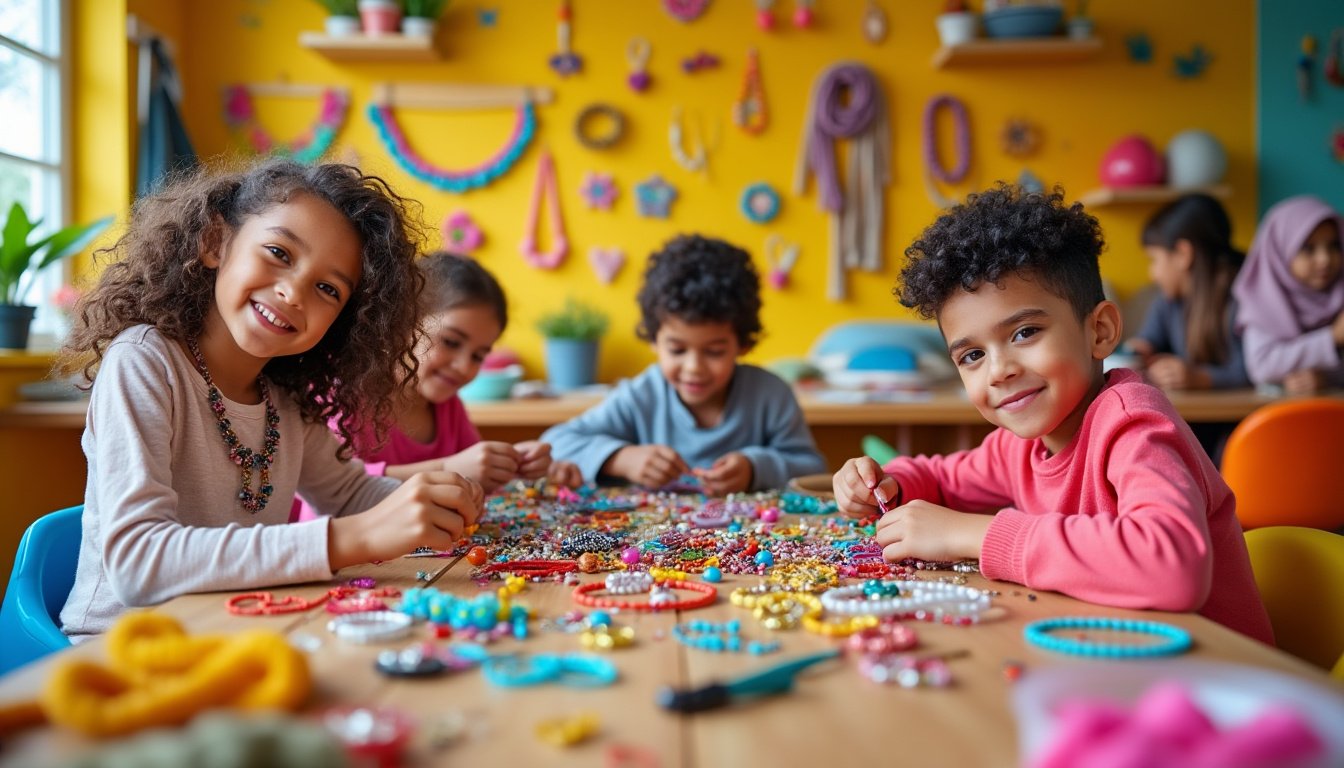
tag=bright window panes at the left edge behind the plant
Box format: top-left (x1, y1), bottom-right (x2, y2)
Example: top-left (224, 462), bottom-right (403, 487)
top-left (0, 0), bottom-right (70, 348)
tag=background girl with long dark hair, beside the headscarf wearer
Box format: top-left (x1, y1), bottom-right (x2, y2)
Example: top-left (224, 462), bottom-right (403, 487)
top-left (1125, 195), bottom-right (1251, 390)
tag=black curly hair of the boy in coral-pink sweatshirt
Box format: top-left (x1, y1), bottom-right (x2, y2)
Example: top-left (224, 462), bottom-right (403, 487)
top-left (892, 184), bottom-right (1105, 320)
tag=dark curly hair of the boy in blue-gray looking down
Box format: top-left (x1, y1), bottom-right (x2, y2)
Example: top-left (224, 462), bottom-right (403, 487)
top-left (634, 234), bottom-right (761, 352)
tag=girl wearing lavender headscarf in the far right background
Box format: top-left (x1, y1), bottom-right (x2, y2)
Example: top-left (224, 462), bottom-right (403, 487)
top-left (1232, 195), bottom-right (1344, 394)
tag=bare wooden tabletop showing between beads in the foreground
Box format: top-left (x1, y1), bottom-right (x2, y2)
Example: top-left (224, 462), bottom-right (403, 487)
top-left (0, 519), bottom-right (1344, 768)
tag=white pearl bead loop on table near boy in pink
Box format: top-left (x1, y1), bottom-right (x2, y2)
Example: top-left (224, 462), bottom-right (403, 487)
top-left (821, 581), bottom-right (989, 625)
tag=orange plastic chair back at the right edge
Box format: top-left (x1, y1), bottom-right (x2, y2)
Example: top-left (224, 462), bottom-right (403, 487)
top-left (1222, 397), bottom-right (1344, 530)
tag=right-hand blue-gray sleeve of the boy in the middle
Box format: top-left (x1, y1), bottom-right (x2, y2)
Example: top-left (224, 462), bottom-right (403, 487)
top-left (742, 371), bottom-right (827, 491)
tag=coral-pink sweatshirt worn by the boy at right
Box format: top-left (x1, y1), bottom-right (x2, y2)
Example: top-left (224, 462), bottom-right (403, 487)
top-left (886, 370), bottom-right (1274, 644)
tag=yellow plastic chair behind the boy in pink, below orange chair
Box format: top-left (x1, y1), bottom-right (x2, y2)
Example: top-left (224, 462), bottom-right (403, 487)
top-left (1246, 526), bottom-right (1344, 681)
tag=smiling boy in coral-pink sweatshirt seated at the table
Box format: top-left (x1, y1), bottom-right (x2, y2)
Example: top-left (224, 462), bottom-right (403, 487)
top-left (833, 187), bottom-right (1273, 643)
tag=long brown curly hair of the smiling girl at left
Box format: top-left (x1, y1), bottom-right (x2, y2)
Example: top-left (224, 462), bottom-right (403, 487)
top-left (59, 160), bottom-right (423, 456)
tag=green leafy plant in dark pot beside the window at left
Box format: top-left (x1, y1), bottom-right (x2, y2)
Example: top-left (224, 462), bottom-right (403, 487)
top-left (0, 203), bottom-right (113, 350)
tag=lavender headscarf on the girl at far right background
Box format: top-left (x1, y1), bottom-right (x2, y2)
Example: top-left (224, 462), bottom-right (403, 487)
top-left (1232, 195), bottom-right (1344, 339)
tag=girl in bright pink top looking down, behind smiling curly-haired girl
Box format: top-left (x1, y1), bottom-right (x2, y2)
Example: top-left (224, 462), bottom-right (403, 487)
top-left (298, 252), bottom-right (581, 519)
